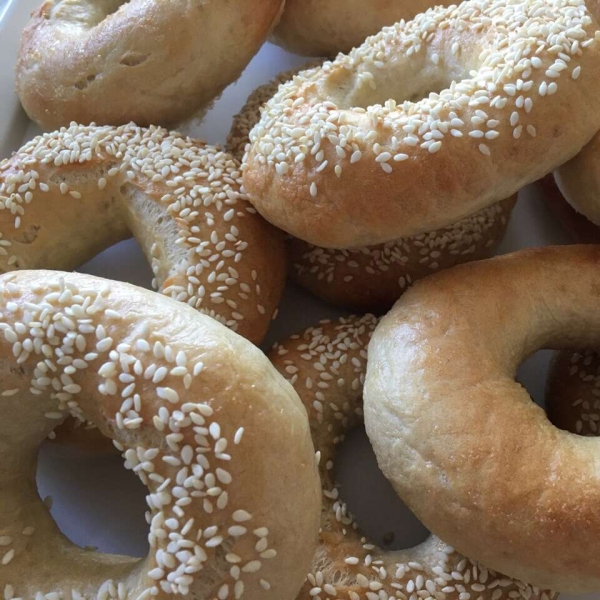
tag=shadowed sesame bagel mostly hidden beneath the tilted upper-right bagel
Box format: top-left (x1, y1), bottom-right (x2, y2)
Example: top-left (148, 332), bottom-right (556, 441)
top-left (226, 68), bottom-right (516, 313)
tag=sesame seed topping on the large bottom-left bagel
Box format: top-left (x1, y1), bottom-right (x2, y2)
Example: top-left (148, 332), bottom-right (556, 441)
top-left (0, 274), bottom-right (277, 600)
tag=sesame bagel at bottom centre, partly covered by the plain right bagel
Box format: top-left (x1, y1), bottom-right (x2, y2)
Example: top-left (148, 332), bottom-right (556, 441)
top-left (269, 315), bottom-right (556, 600)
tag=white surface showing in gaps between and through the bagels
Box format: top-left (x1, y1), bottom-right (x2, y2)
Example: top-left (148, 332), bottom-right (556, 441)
top-left (0, 0), bottom-right (600, 600)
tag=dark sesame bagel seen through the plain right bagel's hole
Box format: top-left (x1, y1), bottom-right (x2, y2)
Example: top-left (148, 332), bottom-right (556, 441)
top-left (546, 350), bottom-right (600, 437)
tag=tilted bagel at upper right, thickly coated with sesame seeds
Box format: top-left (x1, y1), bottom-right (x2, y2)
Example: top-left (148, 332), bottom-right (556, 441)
top-left (244, 0), bottom-right (600, 248)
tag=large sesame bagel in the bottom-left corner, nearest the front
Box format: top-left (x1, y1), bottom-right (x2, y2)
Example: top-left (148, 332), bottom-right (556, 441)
top-left (0, 271), bottom-right (320, 600)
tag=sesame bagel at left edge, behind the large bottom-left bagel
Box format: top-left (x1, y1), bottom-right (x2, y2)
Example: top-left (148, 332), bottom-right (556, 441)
top-left (0, 124), bottom-right (286, 343)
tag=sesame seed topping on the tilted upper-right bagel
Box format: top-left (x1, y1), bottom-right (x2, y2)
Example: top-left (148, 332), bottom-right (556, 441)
top-left (245, 0), bottom-right (597, 231)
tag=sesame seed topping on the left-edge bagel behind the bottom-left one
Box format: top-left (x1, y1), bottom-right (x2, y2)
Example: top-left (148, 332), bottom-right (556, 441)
top-left (0, 124), bottom-right (277, 342)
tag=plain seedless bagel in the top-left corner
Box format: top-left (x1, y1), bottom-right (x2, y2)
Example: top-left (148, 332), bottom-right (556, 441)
top-left (17, 0), bottom-right (283, 129)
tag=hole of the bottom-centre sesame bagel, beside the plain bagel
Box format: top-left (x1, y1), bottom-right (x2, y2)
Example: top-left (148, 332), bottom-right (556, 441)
top-left (334, 427), bottom-right (429, 550)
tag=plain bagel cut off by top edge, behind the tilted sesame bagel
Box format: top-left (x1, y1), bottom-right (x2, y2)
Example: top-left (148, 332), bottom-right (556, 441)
top-left (270, 0), bottom-right (439, 56)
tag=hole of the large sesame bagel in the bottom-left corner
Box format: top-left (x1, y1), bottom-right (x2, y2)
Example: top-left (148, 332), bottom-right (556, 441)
top-left (37, 432), bottom-right (148, 558)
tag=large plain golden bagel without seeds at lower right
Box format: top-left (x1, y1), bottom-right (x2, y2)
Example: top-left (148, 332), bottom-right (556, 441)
top-left (365, 246), bottom-right (600, 593)
